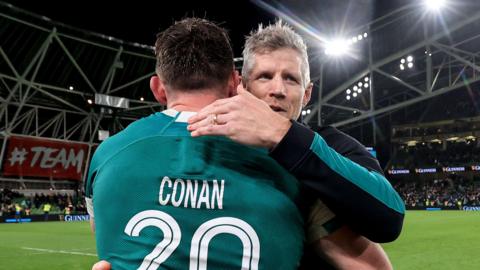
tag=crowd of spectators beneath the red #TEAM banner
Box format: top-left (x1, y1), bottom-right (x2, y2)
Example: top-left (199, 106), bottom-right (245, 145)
top-left (0, 189), bottom-right (87, 216)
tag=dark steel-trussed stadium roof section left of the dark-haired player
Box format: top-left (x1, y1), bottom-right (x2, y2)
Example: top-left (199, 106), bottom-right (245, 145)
top-left (0, 1), bottom-right (278, 144)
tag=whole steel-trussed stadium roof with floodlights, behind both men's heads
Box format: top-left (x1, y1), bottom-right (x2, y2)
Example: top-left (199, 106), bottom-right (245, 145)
top-left (0, 0), bottom-right (480, 148)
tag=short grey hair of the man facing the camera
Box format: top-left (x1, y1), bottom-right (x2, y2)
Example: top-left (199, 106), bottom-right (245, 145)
top-left (242, 20), bottom-right (310, 88)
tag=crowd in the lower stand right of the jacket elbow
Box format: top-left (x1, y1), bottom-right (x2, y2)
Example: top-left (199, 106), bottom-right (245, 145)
top-left (395, 175), bottom-right (480, 209)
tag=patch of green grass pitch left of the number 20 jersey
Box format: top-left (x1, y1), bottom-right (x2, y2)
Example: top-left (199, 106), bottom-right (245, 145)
top-left (0, 221), bottom-right (98, 270)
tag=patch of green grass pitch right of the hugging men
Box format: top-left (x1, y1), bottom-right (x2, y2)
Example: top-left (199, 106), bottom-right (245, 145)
top-left (383, 211), bottom-right (480, 270)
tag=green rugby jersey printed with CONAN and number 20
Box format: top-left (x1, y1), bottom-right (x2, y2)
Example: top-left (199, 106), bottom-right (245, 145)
top-left (85, 110), bottom-right (304, 270)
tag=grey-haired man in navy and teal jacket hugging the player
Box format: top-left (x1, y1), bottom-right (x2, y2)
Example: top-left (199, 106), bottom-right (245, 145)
top-left (189, 22), bottom-right (405, 269)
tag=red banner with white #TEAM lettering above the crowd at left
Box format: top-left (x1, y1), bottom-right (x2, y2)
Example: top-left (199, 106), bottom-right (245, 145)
top-left (2, 136), bottom-right (88, 180)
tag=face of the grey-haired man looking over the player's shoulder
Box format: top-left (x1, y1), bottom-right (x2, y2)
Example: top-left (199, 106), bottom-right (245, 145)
top-left (247, 48), bottom-right (312, 120)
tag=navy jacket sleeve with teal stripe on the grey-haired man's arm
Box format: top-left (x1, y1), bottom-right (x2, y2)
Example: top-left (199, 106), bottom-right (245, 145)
top-left (270, 121), bottom-right (405, 243)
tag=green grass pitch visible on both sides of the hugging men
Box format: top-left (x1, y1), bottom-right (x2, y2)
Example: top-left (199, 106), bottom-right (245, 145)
top-left (0, 211), bottom-right (480, 270)
